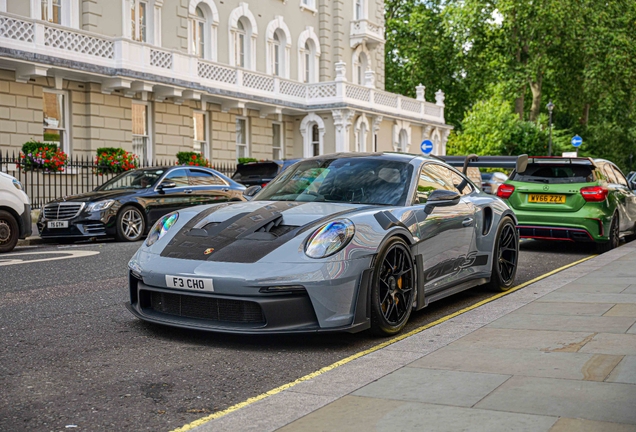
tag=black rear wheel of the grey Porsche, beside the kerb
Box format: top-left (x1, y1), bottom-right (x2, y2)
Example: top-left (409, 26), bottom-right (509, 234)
top-left (486, 217), bottom-right (519, 292)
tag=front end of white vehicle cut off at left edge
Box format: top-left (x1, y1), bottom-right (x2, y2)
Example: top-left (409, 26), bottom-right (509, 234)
top-left (0, 172), bottom-right (31, 252)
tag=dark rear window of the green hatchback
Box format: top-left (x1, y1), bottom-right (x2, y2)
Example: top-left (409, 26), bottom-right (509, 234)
top-left (510, 163), bottom-right (595, 184)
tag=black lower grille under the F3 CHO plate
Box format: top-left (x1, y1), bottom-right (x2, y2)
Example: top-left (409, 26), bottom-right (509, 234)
top-left (149, 291), bottom-right (265, 324)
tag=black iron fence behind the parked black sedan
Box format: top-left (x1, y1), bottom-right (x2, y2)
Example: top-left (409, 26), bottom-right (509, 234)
top-left (0, 151), bottom-right (236, 209)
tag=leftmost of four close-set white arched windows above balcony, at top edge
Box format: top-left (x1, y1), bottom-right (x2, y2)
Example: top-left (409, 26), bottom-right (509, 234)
top-left (188, 0), bottom-right (219, 61)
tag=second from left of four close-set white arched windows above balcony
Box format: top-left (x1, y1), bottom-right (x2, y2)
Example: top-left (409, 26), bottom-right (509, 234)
top-left (229, 3), bottom-right (258, 69)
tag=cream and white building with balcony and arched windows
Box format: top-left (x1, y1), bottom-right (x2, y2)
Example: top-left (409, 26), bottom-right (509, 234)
top-left (0, 0), bottom-right (451, 162)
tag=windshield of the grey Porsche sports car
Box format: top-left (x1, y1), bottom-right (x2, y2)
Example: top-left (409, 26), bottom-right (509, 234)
top-left (255, 157), bottom-right (413, 205)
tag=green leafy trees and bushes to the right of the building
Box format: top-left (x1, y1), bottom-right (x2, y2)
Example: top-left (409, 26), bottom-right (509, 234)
top-left (385, 0), bottom-right (636, 170)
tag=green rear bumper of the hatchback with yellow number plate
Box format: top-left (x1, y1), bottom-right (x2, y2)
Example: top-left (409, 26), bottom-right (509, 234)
top-left (514, 208), bottom-right (612, 242)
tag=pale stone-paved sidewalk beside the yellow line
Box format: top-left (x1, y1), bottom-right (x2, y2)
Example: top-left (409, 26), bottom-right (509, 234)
top-left (195, 242), bottom-right (636, 432)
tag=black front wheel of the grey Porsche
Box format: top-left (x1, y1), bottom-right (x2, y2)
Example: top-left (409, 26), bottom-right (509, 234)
top-left (371, 237), bottom-right (415, 336)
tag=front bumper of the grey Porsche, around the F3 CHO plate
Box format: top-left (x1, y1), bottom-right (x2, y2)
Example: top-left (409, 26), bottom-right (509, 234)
top-left (126, 255), bottom-right (372, 334)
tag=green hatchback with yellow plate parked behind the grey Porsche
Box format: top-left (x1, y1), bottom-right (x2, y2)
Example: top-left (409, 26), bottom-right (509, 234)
top-left (497, 157), bottom-right (636, 252)
